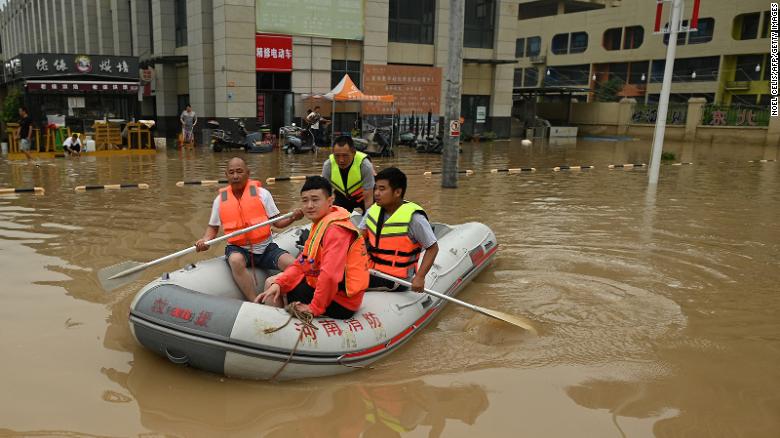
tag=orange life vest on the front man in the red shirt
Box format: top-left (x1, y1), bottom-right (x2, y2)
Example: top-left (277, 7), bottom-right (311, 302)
top-left (297, 206), bottom-right (368, 297)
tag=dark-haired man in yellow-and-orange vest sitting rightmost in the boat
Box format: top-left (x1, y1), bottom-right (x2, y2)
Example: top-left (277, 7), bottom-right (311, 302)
top-left (358, 167), bottom-right (439, 292)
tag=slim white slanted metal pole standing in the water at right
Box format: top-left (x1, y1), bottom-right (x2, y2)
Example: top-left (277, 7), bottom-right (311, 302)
top-left (649, 0), bottom-right (682, 184)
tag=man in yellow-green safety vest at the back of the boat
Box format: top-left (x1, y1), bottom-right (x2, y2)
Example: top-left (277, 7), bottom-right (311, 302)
top-left (322, 135), bottom-right (374, 213)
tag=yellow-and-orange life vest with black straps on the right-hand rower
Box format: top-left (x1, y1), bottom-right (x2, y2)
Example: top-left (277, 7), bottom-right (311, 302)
top-left (366, 201), bottom-right (428, 279)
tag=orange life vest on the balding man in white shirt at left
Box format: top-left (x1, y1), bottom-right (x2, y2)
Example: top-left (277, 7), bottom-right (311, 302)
top-left (219, 179), bottom-right (271, 245)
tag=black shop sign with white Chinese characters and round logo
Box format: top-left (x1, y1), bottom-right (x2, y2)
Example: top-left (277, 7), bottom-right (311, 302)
top-left (20, 53), bottom-right (139, 79)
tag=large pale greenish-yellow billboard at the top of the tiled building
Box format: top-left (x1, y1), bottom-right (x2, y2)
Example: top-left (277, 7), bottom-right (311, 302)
top-left (255, 0), bottom-right (363, 40)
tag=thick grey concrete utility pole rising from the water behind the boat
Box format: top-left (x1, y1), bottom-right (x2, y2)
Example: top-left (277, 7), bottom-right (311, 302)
top-left (441, 0), bottom-right (466, 188)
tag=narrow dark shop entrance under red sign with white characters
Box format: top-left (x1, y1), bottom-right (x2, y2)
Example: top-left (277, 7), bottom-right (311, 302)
top-left (255, 34), bottom-right (293, 132)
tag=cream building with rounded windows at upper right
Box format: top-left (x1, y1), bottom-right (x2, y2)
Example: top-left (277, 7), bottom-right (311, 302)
top-left (513, 0), bottom-right (769, 106)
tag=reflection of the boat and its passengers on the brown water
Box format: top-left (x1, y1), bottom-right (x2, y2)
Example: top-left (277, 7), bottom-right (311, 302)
top-left (101, 342), bottom-right (489, 437)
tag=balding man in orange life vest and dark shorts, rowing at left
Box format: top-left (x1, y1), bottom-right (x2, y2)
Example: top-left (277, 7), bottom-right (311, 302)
top-left (195, 157), bottom-right (303, 301)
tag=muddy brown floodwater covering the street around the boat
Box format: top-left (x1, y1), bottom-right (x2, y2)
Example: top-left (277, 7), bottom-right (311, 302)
top-left (0, 140), bottom-right (780, 437)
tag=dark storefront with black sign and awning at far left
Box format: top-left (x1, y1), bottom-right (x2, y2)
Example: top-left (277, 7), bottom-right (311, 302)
top-left (3, 53), bottom-right (140, 132)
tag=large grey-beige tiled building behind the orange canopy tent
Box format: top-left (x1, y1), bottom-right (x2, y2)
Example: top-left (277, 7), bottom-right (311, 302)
top-left (0, 0), bottom-right (518, 136)
